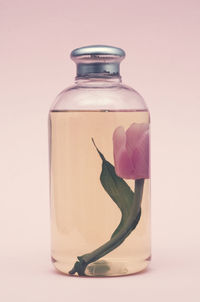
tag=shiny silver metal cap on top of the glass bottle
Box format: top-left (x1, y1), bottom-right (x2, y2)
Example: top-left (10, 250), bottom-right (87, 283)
top-left (71, 45), bottom-right (126, 78)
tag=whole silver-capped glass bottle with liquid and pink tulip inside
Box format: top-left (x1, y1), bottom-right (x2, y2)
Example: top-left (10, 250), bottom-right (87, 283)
top-left (49, 45), bottom-right (151, 277)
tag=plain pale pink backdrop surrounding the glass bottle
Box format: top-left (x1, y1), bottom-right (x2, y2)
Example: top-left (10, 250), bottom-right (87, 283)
top-left (0, 0), bottom-right (200, 302)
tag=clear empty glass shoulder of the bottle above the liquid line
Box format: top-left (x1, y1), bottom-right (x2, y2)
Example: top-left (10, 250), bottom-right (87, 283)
top-left (51, 83), bottom-right (148, 111)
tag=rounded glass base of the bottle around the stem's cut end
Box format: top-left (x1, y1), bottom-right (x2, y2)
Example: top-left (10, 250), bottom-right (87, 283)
top-left (52, 257), bottom-right (150, 277)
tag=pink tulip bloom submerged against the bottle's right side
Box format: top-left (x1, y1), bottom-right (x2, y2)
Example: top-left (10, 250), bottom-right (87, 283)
top-left (113, 123), bottom-right (149, 179)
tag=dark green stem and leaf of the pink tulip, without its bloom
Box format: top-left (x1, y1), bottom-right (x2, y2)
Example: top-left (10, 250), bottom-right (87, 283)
top-left (69, 139), bottom-right (144, 275)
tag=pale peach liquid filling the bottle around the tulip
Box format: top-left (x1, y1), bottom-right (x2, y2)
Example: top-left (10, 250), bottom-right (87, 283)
top-left (50, 111), bottom-right (151, 276)
